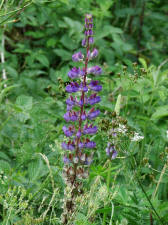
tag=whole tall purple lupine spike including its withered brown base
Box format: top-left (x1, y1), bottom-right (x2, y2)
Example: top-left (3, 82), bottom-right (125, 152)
top-left (62, 14), bottom-right (102, 224)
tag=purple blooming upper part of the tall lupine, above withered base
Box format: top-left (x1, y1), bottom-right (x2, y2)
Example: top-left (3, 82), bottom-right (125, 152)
top-left (62, 14), bottom-right (102, 178)
